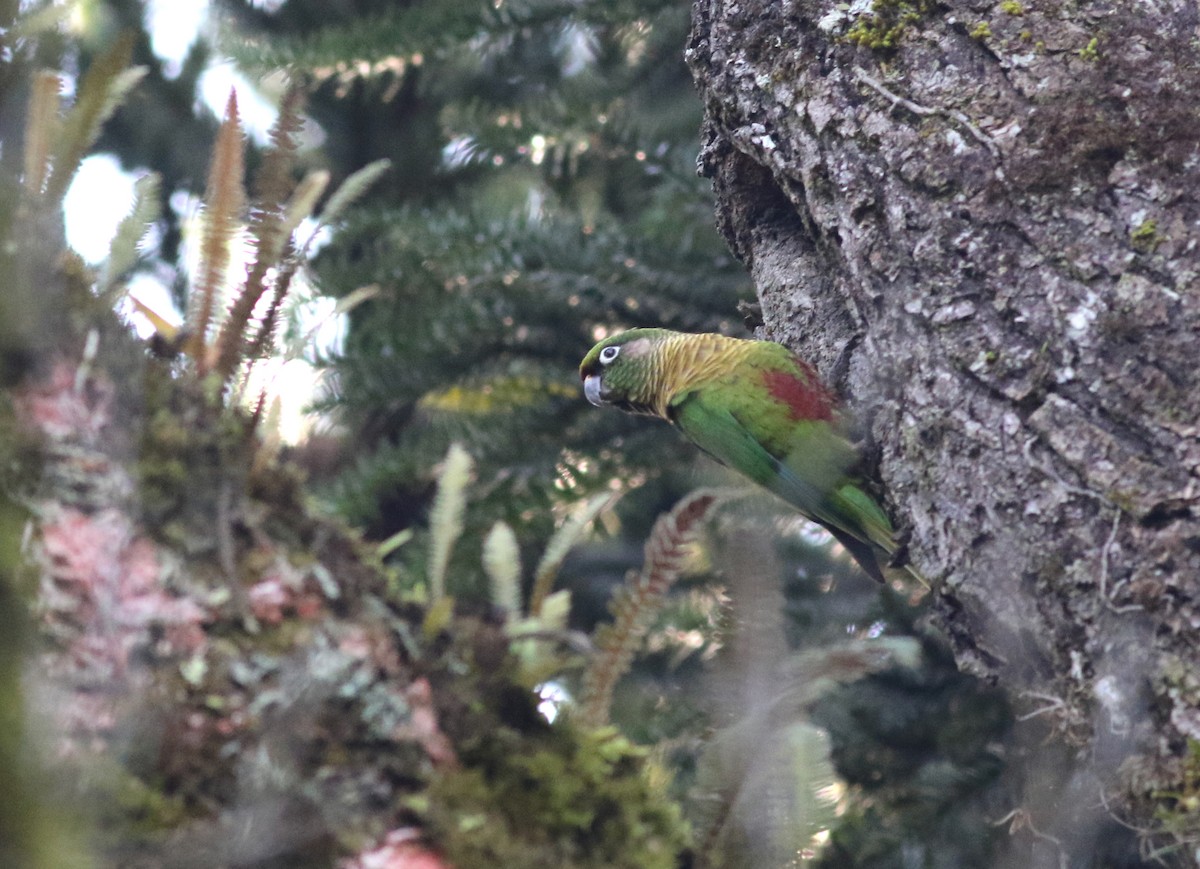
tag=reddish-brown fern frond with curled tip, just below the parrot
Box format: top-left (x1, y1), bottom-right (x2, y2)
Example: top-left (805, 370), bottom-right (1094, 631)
top-left (580, 490), bottom-right (718, 727)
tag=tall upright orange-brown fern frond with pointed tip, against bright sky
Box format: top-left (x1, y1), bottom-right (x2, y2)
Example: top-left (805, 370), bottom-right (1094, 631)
top-left (184, 91), bottom-right (246, 374)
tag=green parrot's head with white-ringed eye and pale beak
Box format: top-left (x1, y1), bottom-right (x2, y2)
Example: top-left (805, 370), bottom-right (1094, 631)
top-left (580, 329), bottom-right (672, 415)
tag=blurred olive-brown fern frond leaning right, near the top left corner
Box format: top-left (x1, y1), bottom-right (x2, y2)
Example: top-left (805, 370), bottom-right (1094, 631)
top-left (46, 32), bottom-right (146, 203)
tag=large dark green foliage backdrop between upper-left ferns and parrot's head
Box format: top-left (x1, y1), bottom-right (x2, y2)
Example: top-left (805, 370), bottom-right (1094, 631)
top-left (213, 0), bottom-right (749, 566)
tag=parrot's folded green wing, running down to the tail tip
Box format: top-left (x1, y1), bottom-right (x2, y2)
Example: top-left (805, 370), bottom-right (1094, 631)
top-left (671, 390), bottom-right (895, 582)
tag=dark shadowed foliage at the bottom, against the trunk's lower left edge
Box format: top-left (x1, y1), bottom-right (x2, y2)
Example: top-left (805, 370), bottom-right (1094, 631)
top-left (812, 633), bottom-right (1010, 868)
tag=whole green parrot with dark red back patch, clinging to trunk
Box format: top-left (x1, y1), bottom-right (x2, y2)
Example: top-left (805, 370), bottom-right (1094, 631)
top-left (580, 329), bottom-right (919, 582)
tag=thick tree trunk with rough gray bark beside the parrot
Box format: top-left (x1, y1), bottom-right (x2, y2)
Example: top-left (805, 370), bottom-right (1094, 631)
top-left (688, 0), bottom-right (1200, 865)
